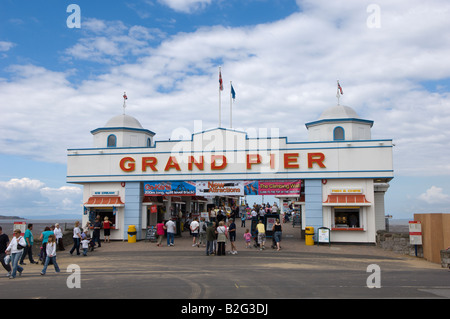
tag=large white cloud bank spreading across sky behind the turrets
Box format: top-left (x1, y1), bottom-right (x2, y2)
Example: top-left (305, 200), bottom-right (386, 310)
top-left (0, 0), bottom-right (450, 180)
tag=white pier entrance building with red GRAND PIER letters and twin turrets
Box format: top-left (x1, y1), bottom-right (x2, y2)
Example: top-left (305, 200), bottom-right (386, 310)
top-left (67, 105), bottom-right (394, 243)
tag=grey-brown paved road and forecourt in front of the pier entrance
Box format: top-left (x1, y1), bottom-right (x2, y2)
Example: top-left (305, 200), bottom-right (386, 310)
top-left (0, 227), bottom-right (450, 302)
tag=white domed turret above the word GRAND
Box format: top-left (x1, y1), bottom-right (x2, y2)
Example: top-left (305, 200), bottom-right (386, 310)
top-left (91, 114), bottom-right (155, 148)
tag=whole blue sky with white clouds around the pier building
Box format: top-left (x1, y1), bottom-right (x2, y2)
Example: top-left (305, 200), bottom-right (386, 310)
top-left (0, 0), bottom-right (450, 218)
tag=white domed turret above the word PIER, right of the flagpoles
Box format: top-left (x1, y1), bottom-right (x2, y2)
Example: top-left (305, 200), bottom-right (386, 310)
top-left (305, 105), bottom-right (373, 141)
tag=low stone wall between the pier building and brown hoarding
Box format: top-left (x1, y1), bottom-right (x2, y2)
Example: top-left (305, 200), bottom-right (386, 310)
top-left (377, 230), bottom-right (423, 258)
